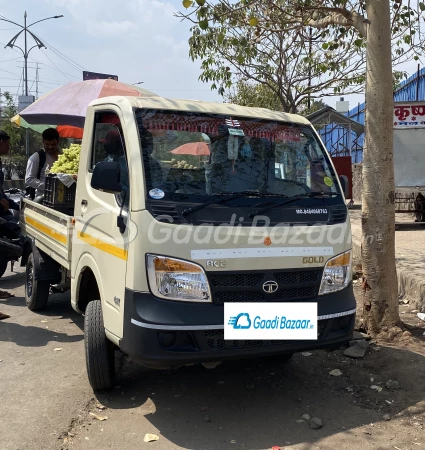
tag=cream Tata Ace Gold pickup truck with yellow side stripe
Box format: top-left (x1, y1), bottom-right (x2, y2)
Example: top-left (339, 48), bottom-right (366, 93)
top-left (21, 97), bottom-right (356, 389)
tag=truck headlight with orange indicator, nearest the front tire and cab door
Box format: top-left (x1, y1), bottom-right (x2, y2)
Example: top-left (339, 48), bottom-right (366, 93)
top-left (147, 255), bottom-right (211, 302)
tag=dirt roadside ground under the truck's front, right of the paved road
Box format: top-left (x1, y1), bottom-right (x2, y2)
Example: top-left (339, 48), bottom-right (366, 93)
top-left (63, 288), bottom-right (425, 450)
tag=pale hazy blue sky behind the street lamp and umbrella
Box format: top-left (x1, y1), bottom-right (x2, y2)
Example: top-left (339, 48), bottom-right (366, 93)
top-left (0, 0), bottom-right (416, 114)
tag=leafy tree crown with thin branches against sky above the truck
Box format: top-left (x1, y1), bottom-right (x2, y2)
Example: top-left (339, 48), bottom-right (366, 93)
top-left (177, 0), bottom-right (425, 114)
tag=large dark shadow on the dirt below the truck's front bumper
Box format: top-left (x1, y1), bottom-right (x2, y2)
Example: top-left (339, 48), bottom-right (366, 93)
top-left (93, 347), bottom-right (425, 449)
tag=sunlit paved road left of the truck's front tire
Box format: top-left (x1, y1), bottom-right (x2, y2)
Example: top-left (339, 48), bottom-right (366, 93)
top-left (0, 268), bottom-right (93, 450)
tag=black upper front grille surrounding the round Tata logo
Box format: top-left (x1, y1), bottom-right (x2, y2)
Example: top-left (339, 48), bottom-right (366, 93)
top-left (207, 268), bottom-right (323, 305)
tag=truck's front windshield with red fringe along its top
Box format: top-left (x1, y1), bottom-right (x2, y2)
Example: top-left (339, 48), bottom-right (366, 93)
top-left (136, 109), bottom-right (338, 201)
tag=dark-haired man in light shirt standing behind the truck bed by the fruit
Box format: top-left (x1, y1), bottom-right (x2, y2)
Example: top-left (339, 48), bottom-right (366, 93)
top-left (25, 128), bottom-right (59, 198)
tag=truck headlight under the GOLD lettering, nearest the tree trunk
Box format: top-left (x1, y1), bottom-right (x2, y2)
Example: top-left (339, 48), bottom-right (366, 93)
top-left (319, 250), bottom-right (352, 295)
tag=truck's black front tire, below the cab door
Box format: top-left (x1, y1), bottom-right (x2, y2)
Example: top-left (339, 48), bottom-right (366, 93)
top-left (84, 300), bottom-right (115, 391)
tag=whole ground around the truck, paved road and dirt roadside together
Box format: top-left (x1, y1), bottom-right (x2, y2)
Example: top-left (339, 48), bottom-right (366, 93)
top-left (0, 273), bottom-right (425, 450)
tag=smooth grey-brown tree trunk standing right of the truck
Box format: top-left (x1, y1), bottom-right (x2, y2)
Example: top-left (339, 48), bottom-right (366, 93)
top-left (362, 0), bottom-right (400, 334)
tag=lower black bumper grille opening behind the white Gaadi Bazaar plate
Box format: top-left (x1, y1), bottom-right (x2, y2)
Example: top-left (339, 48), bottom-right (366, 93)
top-left (204, 320), bottom-right (328, 350)
